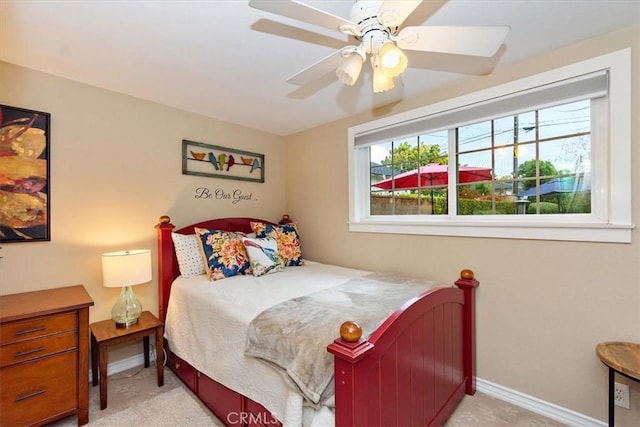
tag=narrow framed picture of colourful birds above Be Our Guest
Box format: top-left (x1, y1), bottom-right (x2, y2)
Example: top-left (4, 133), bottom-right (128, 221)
top-left (182, 139), bottom-right (264, 182)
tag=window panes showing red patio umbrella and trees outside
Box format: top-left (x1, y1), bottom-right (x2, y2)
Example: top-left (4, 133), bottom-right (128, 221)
top-left (369, 98), bottom-right (606, 215)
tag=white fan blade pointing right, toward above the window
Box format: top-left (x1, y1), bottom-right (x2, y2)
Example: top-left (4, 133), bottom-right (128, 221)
top-left (395, 26), bottom-right (510, 56)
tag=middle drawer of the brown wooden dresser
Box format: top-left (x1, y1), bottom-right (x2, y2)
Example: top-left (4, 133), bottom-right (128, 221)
top-left (0, 332), bottom-right (78, 367)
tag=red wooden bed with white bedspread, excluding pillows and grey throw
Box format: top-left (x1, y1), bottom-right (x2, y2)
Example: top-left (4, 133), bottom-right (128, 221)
top-left (156, 216), bottom-right (478, 426)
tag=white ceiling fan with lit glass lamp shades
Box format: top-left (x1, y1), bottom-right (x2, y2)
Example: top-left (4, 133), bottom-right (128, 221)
top-left (249, 0), bottom-right (510, 92)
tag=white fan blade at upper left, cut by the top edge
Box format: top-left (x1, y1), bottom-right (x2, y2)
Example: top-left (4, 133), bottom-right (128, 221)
top-left (249, 0), bottom-right (357, 31)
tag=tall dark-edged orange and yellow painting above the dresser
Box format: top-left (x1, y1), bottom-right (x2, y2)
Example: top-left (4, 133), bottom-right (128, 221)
top-left (0, 105), bottom-right (51, 243)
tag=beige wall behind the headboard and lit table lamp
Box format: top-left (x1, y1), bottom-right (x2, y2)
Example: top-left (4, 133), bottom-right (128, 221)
top-left (0, 62), bottom-right (285, 360)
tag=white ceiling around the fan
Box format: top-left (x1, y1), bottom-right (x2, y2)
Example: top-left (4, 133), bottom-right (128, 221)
top-left (0, 0), bottom-right (640, 135)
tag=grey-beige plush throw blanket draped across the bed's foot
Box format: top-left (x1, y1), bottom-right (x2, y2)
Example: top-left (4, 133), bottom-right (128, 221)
top-left (245, 273), bottom-right (436, 408)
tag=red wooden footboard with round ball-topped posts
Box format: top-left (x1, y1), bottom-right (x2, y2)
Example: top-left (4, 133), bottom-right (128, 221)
top-left (327, 271), bottom-right (478, 427)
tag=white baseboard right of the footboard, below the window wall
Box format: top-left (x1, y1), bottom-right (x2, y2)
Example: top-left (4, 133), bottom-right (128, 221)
top-left (476, 378), bottom-right (607, 427)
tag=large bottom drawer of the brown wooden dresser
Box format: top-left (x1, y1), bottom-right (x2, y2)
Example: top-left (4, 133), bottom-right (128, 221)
top-left (0, 352), bottom-right (78, 426)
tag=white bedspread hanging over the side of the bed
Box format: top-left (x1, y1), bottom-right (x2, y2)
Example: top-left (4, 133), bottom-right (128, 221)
top-left (165, 260), bottom-right (368, 427)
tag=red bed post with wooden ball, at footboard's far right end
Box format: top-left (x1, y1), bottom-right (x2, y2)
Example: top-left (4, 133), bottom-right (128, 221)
top-left (455, 270), bottom-right (480, 395)
